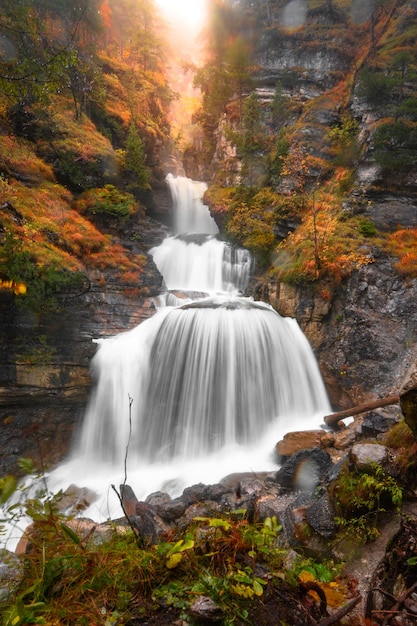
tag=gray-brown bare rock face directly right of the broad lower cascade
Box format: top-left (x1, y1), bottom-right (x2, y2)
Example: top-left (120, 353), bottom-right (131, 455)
top-left (269, 254), bottom-right (417, 408)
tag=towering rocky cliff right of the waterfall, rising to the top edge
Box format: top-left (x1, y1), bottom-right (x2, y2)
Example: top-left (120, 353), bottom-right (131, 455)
top-left (201, 2), bottom-right (417, 408)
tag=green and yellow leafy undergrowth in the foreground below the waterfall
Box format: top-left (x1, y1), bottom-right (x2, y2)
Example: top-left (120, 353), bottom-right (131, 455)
top-left (0, 461), bottom-right (348, 626)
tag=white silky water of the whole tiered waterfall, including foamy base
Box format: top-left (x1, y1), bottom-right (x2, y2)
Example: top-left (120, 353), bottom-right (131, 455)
top-left (2, 176), bottom-right (330, 544)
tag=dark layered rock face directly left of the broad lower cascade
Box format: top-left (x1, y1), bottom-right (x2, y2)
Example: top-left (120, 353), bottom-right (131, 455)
top-left (0, 212), bottom-right (166, 475)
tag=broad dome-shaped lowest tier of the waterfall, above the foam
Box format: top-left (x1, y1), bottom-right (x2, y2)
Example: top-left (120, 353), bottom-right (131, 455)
top-left (81, 296), bottom-right (326, 465)
